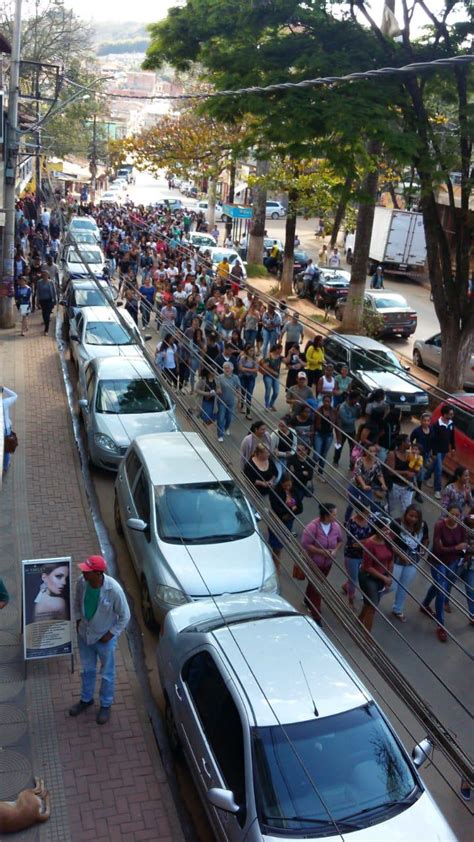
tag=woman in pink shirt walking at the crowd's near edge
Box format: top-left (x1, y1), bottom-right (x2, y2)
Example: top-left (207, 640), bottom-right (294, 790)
top-left (301, 503), bottom-right (342, 625)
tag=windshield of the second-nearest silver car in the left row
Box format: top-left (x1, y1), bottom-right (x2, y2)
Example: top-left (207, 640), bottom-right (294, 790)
top-left (155, 481), bottom-right (255, 544)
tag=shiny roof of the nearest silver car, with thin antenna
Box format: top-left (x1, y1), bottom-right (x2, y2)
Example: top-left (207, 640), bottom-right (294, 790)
top-left (212, 614), bottom-right (368, 726)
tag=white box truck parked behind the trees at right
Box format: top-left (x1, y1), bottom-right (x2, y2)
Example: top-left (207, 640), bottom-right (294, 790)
top-left (369, 207), bottom-right (426, 272)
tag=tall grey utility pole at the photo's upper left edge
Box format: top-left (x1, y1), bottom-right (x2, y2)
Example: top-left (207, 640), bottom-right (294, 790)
top-left (0, 0), bottom-right (21, 328)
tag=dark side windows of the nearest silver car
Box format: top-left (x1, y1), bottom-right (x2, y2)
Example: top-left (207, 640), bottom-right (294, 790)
top-left (183, 652), bottom-right (245, 812)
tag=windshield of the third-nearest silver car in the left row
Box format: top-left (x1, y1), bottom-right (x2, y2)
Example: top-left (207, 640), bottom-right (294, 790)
top-left (95, 378), bottom-right (169, 415)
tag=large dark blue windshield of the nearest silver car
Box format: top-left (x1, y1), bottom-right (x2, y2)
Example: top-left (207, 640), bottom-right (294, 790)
top-left (252, 703), bottom-right (420, 836)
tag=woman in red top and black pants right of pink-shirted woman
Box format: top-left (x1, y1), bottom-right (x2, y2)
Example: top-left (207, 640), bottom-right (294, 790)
top-left (359, 515), bottom-right (393, 632)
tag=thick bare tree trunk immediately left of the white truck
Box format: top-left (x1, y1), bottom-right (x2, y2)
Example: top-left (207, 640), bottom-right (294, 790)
top-left (340, 151), bottom-right (379, 334)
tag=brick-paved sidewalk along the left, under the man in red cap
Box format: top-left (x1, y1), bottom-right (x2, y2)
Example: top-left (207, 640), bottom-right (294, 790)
top-left (0, 313), bottom-right (183, 842)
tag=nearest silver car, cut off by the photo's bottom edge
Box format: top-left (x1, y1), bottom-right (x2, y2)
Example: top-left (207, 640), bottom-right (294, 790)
top-left (157, 595), bottom-right (456, 842)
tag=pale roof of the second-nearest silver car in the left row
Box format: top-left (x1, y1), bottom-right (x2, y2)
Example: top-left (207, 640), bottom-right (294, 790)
top-left (135, 432), bottom-right (230, 485)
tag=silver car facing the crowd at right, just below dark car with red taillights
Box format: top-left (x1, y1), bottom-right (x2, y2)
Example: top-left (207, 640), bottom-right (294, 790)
top-left (324, 333), bottom-right (429, 415)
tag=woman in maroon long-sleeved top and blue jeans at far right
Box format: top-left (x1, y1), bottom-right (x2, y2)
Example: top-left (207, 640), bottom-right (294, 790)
top-left (420, 505), bottom-right (469, 643)
